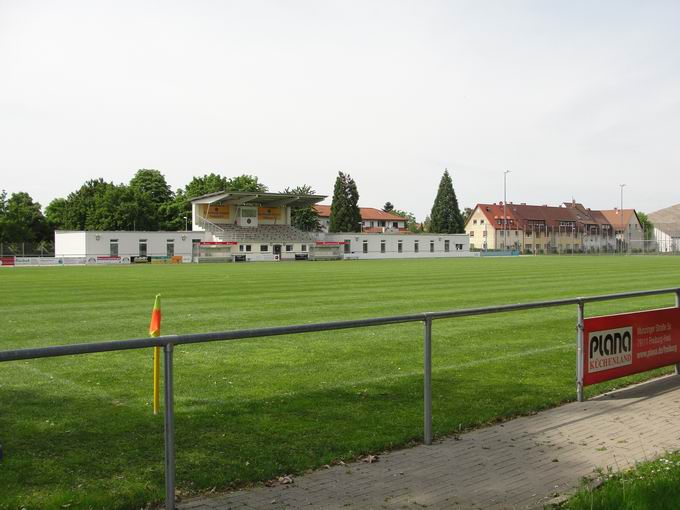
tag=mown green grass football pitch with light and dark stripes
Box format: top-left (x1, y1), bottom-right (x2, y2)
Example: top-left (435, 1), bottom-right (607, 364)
top-left (0, 257), bottom-right (680, 509)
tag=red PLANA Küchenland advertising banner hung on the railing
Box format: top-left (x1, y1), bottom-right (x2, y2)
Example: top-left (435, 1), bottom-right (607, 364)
top-left (583, 308), bottom-right (680, 386)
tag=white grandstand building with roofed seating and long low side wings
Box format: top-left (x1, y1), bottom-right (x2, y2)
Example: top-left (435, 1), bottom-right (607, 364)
top-left (55, 191), bottom-right (470, 264)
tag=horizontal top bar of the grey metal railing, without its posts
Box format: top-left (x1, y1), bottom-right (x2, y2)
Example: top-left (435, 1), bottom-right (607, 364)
top-left (0, 288), bottom-right (680, 362)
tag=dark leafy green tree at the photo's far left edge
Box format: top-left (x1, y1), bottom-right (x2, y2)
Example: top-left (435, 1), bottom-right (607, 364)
top-left (1, 191), bottom-right (51, 242)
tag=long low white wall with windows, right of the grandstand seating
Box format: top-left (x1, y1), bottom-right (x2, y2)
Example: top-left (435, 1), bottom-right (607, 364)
top-left (323, 232), bottom-right (478, 259)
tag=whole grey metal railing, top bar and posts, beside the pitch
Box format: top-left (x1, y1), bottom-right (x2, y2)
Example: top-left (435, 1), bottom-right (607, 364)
top-left (0, 287), bottom-right (680, 510)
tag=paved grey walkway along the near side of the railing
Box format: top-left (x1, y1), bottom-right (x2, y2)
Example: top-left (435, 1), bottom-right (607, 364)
top-left (179, 376), bottom-right (680, 510)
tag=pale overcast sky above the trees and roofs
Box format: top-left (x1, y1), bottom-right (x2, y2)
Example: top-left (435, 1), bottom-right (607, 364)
top-left (0, 0), bottom-right (680, 219)
